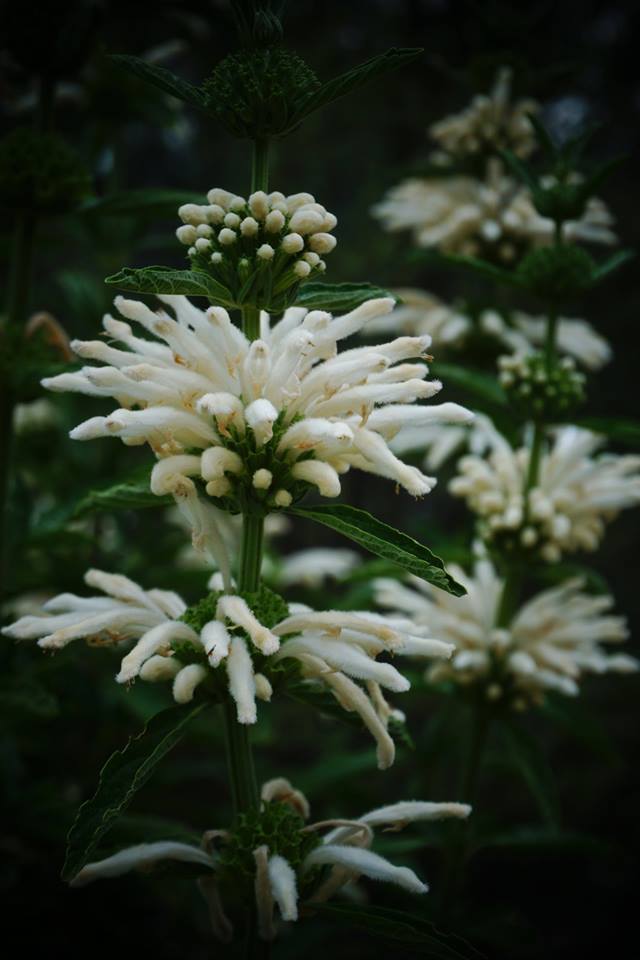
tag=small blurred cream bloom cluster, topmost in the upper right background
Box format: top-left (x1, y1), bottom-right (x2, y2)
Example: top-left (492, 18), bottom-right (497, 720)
top-left (429, 67), bottom-right (539, 157)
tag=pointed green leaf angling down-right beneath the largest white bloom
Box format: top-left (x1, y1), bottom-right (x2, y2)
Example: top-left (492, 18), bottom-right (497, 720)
top-left (288, 503), bottom-right (466, 597)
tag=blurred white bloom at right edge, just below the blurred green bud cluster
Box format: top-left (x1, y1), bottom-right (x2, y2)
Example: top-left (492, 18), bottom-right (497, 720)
top-left (449, 426), bottom-right (640, 563)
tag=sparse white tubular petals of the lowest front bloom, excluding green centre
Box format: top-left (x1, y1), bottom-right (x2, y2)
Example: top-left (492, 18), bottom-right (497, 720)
top-left (71, 777), bottom-right (471, 942)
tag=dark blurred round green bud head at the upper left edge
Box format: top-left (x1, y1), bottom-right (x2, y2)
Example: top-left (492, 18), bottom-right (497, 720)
top-left (0, 128), bottom-right (91, 216)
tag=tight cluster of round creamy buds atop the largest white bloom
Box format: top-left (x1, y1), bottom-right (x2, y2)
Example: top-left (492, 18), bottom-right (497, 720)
top-left (176, 188), bottom-right (337, 312)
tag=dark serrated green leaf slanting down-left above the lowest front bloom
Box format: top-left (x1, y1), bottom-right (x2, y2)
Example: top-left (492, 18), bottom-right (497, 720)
top-left (62, 702), bottom-right (209, 880)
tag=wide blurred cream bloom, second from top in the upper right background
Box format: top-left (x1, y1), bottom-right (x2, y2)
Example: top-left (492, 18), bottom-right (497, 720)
top-left (373, 158), bottom-right (616, 263)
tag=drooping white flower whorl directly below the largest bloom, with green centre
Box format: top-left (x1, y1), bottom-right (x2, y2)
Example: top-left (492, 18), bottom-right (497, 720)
top-left (2, 570), bottom-right (453, 769)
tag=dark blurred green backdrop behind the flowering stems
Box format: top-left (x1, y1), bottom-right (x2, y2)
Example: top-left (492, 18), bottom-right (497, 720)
top-left (0, 0), bottom-right (640, 960)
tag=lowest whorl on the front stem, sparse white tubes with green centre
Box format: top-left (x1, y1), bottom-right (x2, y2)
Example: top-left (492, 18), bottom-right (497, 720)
top-left (71, 777), bottom-right (471, 942)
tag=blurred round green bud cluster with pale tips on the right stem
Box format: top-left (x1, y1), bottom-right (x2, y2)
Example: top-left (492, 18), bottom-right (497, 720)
top-left (498, 353), bottom-right (586, 423)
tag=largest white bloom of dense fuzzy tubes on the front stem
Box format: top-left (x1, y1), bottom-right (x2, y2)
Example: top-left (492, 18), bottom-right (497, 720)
top-left (43, 296), bottom-right (466, 512)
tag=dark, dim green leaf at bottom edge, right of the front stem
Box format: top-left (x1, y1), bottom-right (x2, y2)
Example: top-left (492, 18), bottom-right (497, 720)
top-left (309, 903), bottom-right (483, 960)
